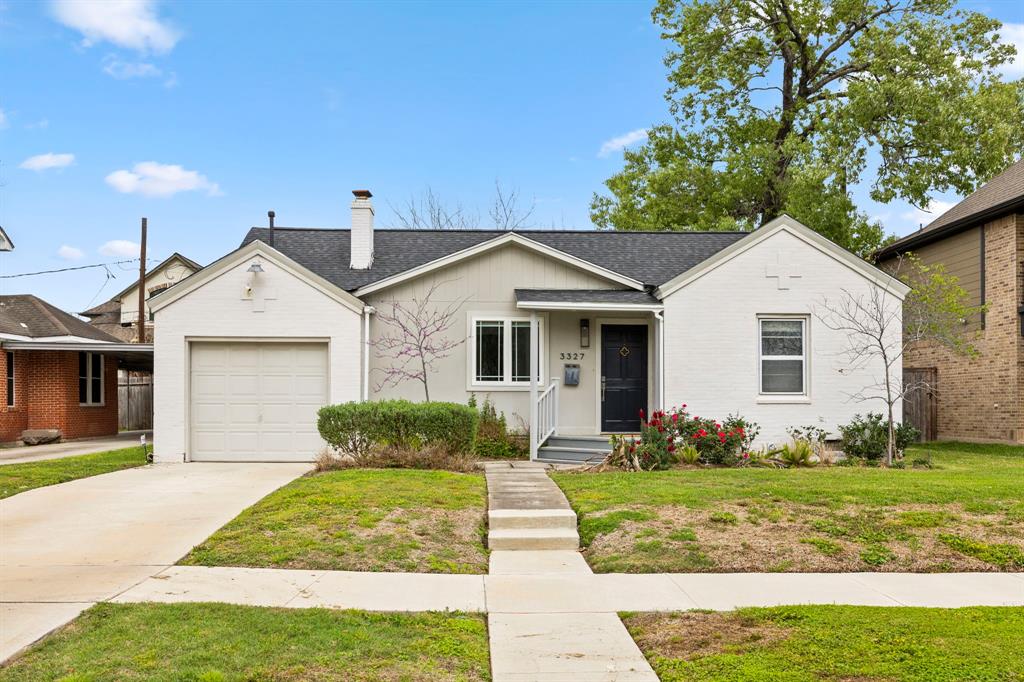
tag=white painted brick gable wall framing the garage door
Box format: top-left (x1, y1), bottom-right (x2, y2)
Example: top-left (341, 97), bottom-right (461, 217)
top-left (154, 254), bottom-right (361, 462)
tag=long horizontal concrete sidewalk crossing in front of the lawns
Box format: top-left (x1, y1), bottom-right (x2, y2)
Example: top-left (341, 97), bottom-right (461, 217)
top-left (113, 551), bottom-right (1024, 614)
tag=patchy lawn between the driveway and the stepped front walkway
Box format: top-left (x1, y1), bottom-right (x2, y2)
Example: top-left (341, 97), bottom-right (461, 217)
top-left (181, 469), bottom-right (487, 573)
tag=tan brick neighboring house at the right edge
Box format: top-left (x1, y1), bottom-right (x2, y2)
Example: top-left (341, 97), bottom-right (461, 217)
top-left (878, 160), bottom-right (1024, 443)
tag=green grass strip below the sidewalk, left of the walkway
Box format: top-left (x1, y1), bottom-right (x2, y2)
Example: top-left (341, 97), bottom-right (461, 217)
top-left (0, 603), bottom-right (489, 682)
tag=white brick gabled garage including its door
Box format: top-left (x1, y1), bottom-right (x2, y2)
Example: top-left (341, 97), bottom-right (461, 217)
top-left (150, 242), bottom-right (369, 462)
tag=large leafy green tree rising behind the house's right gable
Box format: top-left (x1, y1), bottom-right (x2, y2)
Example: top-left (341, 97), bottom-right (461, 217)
top-left (591, 0), bottom-right (1024, 254)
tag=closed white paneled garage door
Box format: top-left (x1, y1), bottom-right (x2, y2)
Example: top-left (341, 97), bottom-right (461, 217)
top-left (189, 342), bottom-right (327, 462)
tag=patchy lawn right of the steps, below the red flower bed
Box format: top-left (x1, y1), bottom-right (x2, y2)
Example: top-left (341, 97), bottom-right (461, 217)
top-left (553, 443), bottom-right (1024, 572)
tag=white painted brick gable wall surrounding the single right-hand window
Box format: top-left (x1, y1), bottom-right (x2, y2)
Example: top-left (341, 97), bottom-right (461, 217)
top-left (665, 225), bottom-right (902, 444)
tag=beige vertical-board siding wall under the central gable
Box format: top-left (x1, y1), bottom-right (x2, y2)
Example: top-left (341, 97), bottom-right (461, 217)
top-left (366, 240), bottom-right (621, 433)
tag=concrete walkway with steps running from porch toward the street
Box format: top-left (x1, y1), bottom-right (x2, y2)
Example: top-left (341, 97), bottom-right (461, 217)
top-left (483, 462), bottom-right (657, 682)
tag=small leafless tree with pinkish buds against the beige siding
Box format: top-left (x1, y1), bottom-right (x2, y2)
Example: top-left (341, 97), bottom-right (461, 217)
top-left (370, 282), bottom-right (466, 402)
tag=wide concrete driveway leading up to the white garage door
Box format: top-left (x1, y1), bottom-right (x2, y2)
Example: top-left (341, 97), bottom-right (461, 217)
top-left (0, 464), bottom-right (310, 660)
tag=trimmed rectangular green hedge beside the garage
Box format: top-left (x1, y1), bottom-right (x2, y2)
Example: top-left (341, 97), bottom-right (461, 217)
top-left (316, 400), bottom-right (479, 457)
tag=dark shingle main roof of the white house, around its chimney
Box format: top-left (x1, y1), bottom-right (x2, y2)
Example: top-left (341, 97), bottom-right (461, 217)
top-left (242, 227), bottom-right (749, 291)
